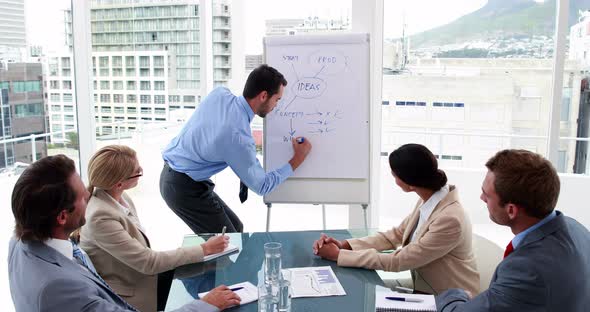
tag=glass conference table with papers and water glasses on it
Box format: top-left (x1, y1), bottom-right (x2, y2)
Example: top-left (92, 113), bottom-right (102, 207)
top-left (166, 230), bottom-right (383, 312)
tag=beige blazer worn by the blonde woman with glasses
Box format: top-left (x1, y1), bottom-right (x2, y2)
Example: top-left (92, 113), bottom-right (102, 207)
top-left (80, 189), bottom-right (203, 312)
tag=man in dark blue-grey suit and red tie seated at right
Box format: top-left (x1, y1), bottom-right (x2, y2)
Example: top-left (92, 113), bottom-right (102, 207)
top-left (436, 150), bottom-right (590, 312)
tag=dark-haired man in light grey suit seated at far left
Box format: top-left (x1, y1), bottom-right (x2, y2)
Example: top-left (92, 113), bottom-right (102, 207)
top-left (8, 155), bottom-right (239, 312)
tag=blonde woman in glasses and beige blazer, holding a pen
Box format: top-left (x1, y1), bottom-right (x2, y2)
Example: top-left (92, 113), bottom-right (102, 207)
top-left (80, 145), bottom-right (239, 312)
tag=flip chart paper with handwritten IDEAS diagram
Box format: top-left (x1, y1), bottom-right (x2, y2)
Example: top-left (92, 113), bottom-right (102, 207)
top-left (264, 36), bottom-right (369, 179)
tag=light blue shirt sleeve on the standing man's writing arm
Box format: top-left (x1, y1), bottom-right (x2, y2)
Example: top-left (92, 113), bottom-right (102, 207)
top-left (223, 130), bottom-right (293, 195)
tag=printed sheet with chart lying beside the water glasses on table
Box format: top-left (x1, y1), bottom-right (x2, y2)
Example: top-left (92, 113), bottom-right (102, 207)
top-left (285, 266), bottom-right (346, 298)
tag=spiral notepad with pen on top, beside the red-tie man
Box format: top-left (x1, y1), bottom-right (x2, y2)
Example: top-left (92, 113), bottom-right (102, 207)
top-left (375, 286), bottom-right (436, 312)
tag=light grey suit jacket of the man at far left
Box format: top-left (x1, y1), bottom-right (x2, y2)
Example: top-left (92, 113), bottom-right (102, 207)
top-left (8, 237), bottom-right (217, 312)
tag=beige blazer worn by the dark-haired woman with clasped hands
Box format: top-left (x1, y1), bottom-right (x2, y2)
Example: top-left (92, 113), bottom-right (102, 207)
top-left (338, 185), bottom-right (479, 295)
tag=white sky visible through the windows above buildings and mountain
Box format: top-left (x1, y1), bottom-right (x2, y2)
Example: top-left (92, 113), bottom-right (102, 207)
top-left (25, 0), bottom-right (494, 54)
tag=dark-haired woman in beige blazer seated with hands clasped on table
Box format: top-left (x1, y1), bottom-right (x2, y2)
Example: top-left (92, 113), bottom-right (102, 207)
top-left (313, 144), bottom-right (479, 295)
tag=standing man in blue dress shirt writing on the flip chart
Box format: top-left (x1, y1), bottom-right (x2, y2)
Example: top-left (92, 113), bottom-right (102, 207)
top-left (160, 65), bottom-right (311, 233)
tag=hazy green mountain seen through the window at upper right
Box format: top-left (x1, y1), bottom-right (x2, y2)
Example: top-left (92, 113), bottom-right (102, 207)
top-left (410, 0), bottom-right (590, 49)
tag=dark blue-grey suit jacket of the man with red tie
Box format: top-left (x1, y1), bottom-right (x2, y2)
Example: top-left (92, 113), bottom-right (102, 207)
top-left (436, 211), bottom-right (590, 312)
